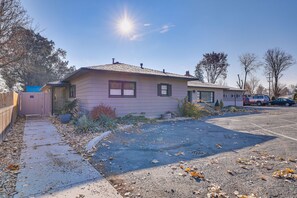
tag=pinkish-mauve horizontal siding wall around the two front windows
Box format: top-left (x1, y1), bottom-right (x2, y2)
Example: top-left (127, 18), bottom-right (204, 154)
top-left (70, 71), bottom-right (187, 117)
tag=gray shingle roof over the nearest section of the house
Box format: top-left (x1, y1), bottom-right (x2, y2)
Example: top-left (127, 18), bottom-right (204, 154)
top-left (84, 63), bottom-right (196, 80)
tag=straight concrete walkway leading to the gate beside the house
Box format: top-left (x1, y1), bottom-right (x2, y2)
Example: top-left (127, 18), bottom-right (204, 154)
top-left (14, 117), bottom-right (121, 198)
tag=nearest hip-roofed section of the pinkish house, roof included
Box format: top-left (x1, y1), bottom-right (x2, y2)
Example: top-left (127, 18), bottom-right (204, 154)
top-left (42, 62), bottom-right (196, 117)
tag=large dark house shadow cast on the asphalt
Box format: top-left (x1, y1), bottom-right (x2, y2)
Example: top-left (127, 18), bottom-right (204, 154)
top-left (92, 120), bottom-right (275, 176)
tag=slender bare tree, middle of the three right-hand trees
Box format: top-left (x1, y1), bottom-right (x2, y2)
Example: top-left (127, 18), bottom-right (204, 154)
top-left (239, 53), bottom-right (261, 89)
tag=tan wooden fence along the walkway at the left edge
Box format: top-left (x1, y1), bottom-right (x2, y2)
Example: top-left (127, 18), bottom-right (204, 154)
top-left (0, 92), bottom-right (18, 142)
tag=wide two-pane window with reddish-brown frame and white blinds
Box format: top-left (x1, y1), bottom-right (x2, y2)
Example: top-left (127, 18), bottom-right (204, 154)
top-left (109, 81), bottom-right (136, 98)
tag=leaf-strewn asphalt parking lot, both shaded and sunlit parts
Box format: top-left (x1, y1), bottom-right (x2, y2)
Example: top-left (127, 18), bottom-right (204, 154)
top-left (92, 107), bottom-right (297, 197)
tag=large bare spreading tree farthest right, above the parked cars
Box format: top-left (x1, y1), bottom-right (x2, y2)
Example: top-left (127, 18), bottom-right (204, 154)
top-left (264, 48), bottom-right (295, 97)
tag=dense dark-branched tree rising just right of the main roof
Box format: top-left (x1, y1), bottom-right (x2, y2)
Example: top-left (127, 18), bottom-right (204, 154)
top-left (197, 52), bottom-right (229, 84)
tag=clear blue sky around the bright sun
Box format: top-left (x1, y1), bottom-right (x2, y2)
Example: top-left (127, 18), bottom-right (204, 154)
top-left (22, 0), bottom-right (297, 86)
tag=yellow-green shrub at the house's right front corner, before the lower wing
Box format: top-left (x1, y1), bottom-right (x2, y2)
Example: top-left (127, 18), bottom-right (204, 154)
top-left (179, 98), bottom-right (201, 118)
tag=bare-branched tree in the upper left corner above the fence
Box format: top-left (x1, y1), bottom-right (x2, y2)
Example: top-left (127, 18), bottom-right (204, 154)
top-left (0, 0), bottom-right (30, 69)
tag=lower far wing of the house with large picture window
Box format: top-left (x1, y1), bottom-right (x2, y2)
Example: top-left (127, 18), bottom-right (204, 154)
top-left (188, 81), bottom-right (244, 106)
